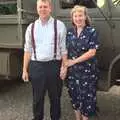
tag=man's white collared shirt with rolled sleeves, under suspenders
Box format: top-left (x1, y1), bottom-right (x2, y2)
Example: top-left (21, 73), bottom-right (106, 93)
top-left (24, 17), bottom-right (67, 61)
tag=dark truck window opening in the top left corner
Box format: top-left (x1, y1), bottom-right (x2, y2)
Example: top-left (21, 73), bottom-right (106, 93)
top-left (0, 0), bottom-right (17, 15)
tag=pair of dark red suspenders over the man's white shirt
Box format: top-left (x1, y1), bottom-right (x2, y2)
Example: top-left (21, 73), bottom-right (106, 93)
top-left (31, 19), bottom-right (57, 60)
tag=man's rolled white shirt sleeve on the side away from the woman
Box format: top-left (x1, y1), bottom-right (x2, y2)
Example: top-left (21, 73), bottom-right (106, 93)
top-left (24, 24), bottom-right (32, 53)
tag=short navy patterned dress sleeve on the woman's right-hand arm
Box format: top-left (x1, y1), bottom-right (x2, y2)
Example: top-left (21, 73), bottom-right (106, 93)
top-left (89, 28), bottom-right (100, 49)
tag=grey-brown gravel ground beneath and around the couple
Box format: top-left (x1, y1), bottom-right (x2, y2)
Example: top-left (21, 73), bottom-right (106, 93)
top-left (0, 82), bottom-right (120, 120)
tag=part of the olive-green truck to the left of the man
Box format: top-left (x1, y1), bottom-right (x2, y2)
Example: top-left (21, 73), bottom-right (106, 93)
top-left (0, 0), bottom-right (37, 80)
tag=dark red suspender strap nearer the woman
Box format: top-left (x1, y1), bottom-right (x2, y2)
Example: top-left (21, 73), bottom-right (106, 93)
top-left (54, 19), bottom-right (57, 59)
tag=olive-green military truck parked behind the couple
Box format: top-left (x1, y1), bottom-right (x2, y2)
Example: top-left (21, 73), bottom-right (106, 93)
top-left (0, 0), bottom-right (120, 90)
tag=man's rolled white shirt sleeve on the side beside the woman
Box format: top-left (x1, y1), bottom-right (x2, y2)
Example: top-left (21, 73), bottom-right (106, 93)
top-left (60, 23), bottom-right (67, 55)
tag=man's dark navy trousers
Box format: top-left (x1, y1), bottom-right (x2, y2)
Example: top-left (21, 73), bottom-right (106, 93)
top-left (29, 60), bottom-right (62, 120)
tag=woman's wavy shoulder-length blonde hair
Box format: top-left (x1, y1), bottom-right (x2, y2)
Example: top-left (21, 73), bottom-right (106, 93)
top-left (71, 5), bottom-right (91, 26)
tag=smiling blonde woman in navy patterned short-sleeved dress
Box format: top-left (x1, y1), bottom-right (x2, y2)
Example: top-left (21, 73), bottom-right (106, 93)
top-left (66, 5), bottom-right (99, 120)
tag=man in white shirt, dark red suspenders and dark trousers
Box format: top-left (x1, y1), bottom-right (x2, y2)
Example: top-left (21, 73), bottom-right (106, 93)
top-left (22, 0), bottom-right (67, 120)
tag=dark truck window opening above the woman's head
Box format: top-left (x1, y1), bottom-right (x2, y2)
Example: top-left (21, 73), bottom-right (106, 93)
top-left (60, 0), bottom-right (105, 9)
